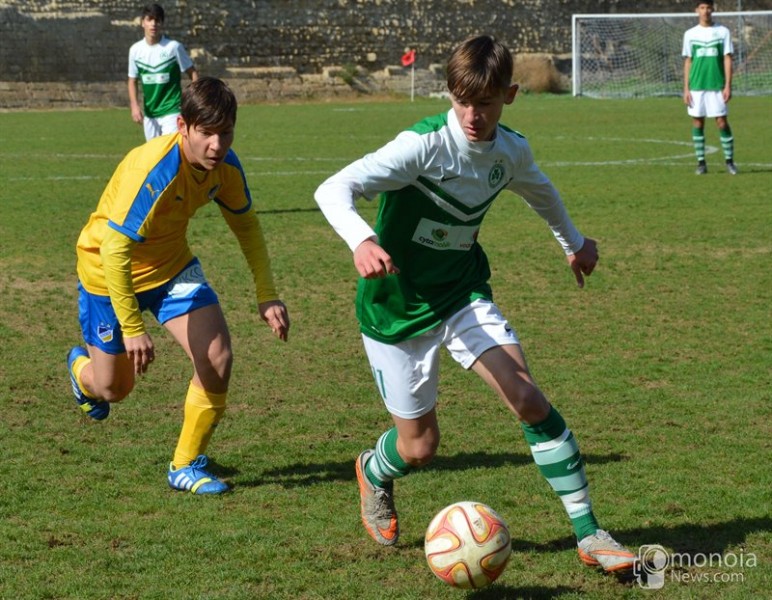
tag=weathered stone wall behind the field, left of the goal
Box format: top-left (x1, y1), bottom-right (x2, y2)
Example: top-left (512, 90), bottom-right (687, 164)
top-left (0, 0), bottom-right (768, 108)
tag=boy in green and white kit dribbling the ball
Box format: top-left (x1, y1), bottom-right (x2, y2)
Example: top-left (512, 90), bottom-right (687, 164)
top-left (315, 36), bottom-right (634, 571)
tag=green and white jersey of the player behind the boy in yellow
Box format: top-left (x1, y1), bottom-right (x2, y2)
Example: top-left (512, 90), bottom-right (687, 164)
top-left (129, 37), bottom-right (193, 118)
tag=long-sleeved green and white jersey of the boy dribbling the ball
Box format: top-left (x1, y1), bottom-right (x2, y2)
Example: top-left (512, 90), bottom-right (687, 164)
top-left (316, 110), bottom-right (584, 343)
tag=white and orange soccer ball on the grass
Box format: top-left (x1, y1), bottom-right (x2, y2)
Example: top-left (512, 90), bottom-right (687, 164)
top-left (424, 502), bottom-right (512, 589)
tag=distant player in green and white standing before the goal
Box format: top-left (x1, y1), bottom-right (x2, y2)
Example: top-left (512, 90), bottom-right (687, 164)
top-left (681, 0), bottom-right (737, 175)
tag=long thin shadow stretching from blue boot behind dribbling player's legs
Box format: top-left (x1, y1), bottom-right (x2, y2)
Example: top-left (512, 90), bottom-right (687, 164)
top-left (243, 452), bottom-right (626, 487)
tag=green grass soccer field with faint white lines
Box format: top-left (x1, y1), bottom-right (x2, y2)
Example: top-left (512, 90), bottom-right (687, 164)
top-left (0, 96), bottom-right (772, 600)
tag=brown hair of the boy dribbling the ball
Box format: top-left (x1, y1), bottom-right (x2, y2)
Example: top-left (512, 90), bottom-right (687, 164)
top-left (447, 35), bottom-right (515, 100)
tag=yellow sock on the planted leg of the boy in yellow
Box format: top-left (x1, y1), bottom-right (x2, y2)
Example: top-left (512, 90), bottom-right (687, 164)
top-left (172, 382), bottom-right (228, 469)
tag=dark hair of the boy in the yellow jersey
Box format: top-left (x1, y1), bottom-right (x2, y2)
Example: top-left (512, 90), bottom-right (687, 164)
top-left (180, 77), bottom-right (238, 130)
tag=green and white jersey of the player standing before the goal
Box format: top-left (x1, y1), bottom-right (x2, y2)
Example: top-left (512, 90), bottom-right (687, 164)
top-left (681, 23), bottom-right (734, 91)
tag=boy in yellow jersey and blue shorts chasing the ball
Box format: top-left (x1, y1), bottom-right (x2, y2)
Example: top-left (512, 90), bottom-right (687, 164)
top-left (67, 77), bottom-right (290, 494)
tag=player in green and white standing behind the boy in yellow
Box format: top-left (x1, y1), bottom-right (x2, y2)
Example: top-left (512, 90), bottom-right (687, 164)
top-left (129, 4), bottom-right (198, 140)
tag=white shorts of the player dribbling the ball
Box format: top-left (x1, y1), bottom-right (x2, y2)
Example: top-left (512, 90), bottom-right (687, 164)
top-left (362, 300), bottom-right (520, 419)
